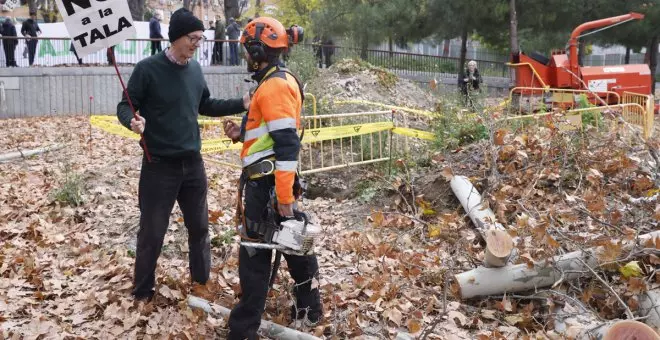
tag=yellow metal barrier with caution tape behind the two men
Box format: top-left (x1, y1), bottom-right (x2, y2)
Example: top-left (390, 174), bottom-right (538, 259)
top-left (90, 110), bottom-right (435, 174)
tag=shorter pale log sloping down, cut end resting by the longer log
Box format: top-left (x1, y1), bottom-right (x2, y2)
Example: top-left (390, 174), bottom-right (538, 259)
top-left (450, 176), bottom-right (514, 267)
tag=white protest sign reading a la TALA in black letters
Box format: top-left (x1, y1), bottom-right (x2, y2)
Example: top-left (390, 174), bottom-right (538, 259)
top-left (57, 0), bottom-right (135, 58)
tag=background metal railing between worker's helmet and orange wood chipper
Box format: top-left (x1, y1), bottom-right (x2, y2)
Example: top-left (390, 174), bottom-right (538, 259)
top-left (296, 44), bottom-right (509, 77)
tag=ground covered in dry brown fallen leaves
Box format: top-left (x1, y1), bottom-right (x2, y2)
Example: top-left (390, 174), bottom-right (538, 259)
top-left (0, 110), bottom-right (660, 339)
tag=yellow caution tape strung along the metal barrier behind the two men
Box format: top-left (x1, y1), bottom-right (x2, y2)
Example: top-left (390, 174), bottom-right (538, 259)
top-left (90, 116), bottom-right (435, 154)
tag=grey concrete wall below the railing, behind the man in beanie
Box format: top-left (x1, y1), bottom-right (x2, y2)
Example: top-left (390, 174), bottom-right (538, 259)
top-left (0, 67), bottom-right (250, 119)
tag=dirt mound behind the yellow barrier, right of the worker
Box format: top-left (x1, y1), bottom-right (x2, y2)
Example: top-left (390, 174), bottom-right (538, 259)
top-left (307, 59), bottom-right (436, 110)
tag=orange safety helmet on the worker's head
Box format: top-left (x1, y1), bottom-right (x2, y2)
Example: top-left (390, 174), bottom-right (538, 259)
top-left (241, 17), bottom-right (289, 49)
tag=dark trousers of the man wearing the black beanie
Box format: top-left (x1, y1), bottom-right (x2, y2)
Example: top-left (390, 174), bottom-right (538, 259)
top-left (133, 154), bottom-right (211, 299)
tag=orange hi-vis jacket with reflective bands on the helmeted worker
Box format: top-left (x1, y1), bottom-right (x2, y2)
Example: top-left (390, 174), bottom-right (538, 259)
top-left (241, 66), bottom-right (303, 204)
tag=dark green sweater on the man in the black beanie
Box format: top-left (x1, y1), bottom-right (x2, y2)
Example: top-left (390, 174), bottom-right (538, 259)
top-left (117, 51), bottom-right (245, 157)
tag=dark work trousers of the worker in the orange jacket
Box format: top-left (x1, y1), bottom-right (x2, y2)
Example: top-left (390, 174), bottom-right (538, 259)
top-left (229, 175), bottom-right (322, 340)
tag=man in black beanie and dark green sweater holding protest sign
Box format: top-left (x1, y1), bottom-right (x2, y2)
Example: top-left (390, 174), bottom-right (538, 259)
top-left (117, 8), bottom-right (250, 300)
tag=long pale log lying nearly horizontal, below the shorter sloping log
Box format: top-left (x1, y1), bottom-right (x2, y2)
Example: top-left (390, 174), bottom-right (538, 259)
top-left (454, 231), bottom-right (660, 299)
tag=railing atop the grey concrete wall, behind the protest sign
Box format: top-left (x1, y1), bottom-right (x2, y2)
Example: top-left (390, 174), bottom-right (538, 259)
top-left (0, 36), bottom-right (245, 67)
